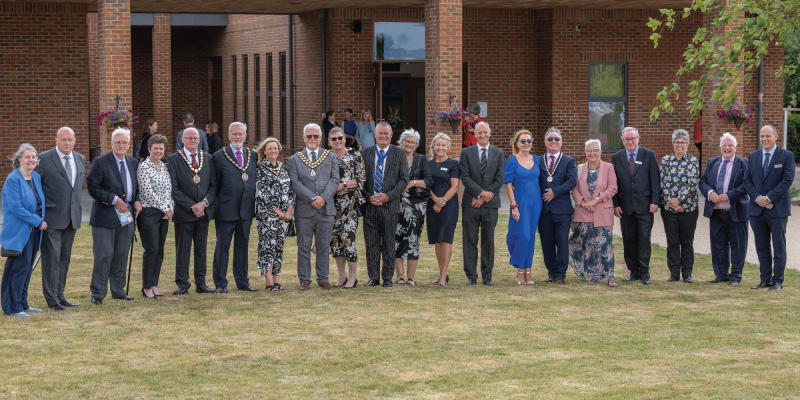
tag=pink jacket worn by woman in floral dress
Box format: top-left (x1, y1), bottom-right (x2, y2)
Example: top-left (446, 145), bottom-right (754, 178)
top-left (568, 161), bottom-right (617, 226)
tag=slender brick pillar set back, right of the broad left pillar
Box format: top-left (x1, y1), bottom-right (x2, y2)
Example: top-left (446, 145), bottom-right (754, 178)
top-left (153, 14), bottom-right (175, 151)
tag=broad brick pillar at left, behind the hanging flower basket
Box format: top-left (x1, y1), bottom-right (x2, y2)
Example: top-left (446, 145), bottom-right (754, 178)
top-left (97, 0), bottom-right (133, 153)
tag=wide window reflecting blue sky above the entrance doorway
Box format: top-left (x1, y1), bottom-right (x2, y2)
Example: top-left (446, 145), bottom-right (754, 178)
top-left (375, 22), bottom-right (425, 60)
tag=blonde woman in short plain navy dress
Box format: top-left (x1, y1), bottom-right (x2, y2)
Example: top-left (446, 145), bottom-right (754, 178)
top-left (427, 132), bottom-right (461, 286)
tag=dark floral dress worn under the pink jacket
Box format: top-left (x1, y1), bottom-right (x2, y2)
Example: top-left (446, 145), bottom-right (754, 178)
top-left (569, 164), bottom-right (614, 282)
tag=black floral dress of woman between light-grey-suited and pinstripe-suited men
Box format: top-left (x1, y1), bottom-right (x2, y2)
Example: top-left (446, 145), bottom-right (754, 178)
top-left (331, 149), bottom-right (365, 262)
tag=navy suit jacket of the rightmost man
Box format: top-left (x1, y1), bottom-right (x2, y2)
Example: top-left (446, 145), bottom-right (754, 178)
top-left (744, 146), bottom-right (794, 218)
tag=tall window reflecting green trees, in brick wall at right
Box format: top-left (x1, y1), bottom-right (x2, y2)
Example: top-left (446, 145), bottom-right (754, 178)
top-left (589, 62), bottom-right (628, 151)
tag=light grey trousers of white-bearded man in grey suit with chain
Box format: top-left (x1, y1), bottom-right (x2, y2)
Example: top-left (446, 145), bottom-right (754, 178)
top-left (295, 214), bottom-right (334, 284)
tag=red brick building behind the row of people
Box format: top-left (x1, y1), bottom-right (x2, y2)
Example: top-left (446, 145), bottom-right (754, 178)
top-left (0, 0), bottom-right (783, 181)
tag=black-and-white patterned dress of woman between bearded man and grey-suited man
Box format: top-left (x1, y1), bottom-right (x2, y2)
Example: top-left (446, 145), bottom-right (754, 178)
top-left (256, 158), bottom-right (295, 275)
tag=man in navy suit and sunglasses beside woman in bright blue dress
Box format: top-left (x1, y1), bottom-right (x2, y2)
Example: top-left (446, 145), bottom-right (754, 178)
top-left (539, 127), bottom-right (578, 285)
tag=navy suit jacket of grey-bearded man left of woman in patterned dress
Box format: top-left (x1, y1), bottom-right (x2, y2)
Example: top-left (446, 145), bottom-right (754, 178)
top-left (213, 146), bottom-right (258, 221)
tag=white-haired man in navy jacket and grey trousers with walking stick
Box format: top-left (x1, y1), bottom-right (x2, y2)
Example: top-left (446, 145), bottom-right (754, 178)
top-left (86, 128), bottom-right (142, 305)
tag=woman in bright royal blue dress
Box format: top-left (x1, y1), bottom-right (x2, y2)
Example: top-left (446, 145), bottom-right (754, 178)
top-left (504, 130), bottom-right (542, 285)
